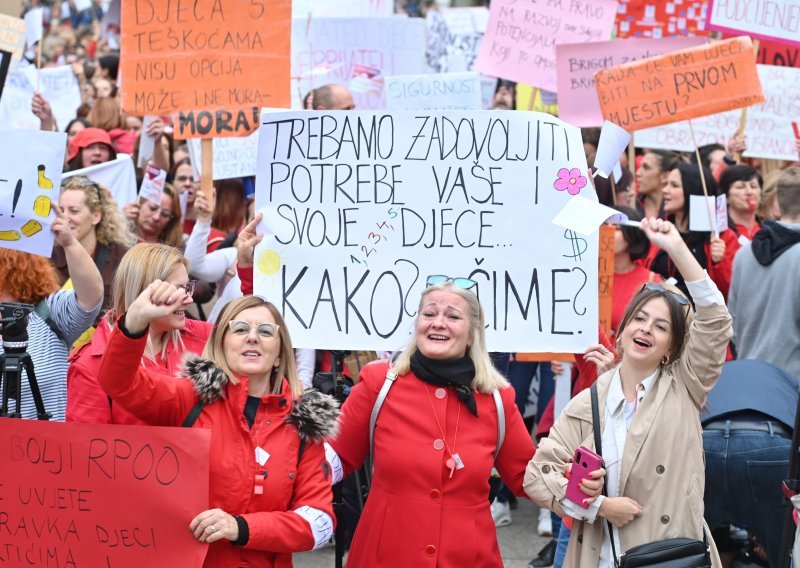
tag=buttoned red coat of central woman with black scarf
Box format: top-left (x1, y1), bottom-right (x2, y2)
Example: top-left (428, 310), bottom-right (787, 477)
top-left (331, 362), bottom-right (535, 568)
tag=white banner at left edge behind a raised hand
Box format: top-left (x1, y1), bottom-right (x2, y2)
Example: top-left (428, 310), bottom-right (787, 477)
top-left (0, 65), bottom-right (81, 131)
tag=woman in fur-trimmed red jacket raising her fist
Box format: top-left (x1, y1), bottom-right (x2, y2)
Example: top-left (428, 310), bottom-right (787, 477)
top-left (100, 290), bottom-right (338, 568)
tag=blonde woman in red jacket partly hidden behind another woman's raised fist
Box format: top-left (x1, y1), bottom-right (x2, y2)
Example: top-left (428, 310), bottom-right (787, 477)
top-left (67, 244), bottom-right (211, 424)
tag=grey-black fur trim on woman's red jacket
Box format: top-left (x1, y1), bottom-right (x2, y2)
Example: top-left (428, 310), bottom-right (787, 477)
top-left (181, 353), bottom-right (339, 443)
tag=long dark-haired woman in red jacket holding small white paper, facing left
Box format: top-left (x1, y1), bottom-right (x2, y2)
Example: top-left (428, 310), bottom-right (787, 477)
top-left (645, 164), bottom-right (741, 298)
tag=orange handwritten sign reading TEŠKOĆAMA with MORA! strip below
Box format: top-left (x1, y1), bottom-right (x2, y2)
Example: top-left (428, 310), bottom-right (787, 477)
top-left (121, 0), bottom-right (291, 138)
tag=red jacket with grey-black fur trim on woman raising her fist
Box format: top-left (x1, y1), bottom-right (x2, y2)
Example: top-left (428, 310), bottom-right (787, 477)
top-left (99, 325), bottom-right (338, 568)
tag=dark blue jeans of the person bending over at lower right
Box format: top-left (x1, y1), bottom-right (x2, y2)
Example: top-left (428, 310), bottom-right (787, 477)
top-left (703, 422), bottom-right (792, 566)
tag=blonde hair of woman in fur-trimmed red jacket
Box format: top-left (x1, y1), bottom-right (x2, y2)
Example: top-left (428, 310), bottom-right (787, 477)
top-left (203, 296), bottom-right (303, 397)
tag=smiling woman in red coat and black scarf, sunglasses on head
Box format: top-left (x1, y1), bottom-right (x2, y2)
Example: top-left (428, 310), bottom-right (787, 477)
top-left (329, 275), bottom-right (600, 568)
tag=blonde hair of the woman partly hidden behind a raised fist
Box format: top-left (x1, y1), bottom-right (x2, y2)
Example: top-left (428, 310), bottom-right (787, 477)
top-left (106, 243), bottom-right (189, 357)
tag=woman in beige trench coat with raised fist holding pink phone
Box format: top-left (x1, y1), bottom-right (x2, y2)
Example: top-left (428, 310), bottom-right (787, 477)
top-left (525, 219), bottom-right (731, 568)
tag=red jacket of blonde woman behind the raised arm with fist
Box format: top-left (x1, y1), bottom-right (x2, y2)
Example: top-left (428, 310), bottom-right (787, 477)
top-left (67, 317), bottom-right (213, 424)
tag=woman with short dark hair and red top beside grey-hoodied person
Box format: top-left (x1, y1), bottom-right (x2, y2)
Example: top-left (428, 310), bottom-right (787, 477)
top-left (719, 165), bottom-right (764, 244)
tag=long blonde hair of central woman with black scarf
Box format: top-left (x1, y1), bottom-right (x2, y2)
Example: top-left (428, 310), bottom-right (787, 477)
top-left (392, 281), bottom-right (509, 394)
